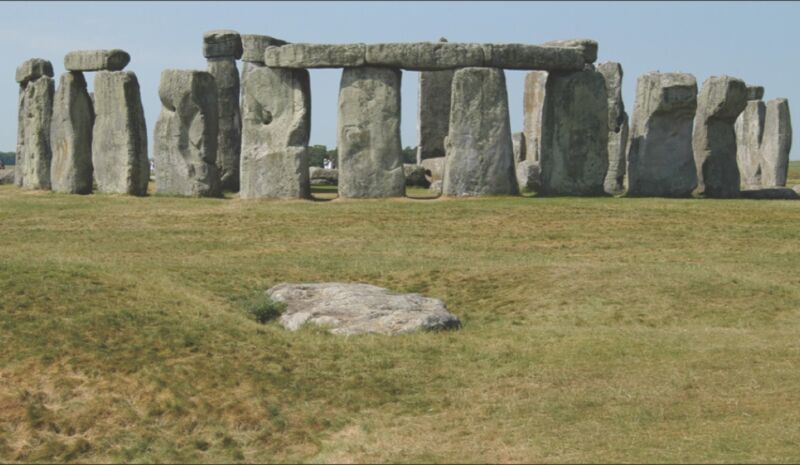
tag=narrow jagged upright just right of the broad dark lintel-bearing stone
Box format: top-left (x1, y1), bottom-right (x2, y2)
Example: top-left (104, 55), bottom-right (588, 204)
top-left (597, 62), bottom-right (628, 195)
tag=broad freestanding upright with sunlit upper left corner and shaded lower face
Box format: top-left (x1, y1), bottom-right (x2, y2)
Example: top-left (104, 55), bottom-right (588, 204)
top-left (628, 73), bottom-right (697, 197)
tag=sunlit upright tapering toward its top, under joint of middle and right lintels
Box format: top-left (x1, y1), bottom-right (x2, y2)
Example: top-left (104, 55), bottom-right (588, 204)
top-left (442, 68), bottom-right (519, 196)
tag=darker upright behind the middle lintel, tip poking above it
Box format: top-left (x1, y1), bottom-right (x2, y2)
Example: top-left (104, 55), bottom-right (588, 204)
top-left (417, 38), bottom-right (455, 164)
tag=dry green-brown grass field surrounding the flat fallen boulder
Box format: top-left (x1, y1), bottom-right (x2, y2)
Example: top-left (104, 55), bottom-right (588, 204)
top-left (0, 163), bottom-right (800, 462)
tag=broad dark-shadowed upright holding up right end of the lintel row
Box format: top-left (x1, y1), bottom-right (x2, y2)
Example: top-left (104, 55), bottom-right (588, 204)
top-left (539, 69), bottom-right (608, 195)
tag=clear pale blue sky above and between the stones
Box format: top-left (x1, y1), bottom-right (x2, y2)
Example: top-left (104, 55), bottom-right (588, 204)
top-left (0, 2), bottom-right (800, 159)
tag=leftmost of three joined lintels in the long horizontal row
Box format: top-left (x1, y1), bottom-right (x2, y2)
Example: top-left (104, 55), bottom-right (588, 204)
top-left (264, 44), bottom-right (367, 68)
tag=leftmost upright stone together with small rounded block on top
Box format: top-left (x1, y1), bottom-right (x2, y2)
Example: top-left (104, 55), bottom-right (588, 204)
top-left (14, 58), bottom-right (55, 189)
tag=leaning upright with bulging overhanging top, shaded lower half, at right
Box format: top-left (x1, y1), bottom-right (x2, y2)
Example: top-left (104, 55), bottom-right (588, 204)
top-left (692, 76), bottom-right (747, 198)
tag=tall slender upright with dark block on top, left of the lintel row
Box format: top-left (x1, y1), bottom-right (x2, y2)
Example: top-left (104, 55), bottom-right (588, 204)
top-left (203, 30), bottom-right (243, 191)
